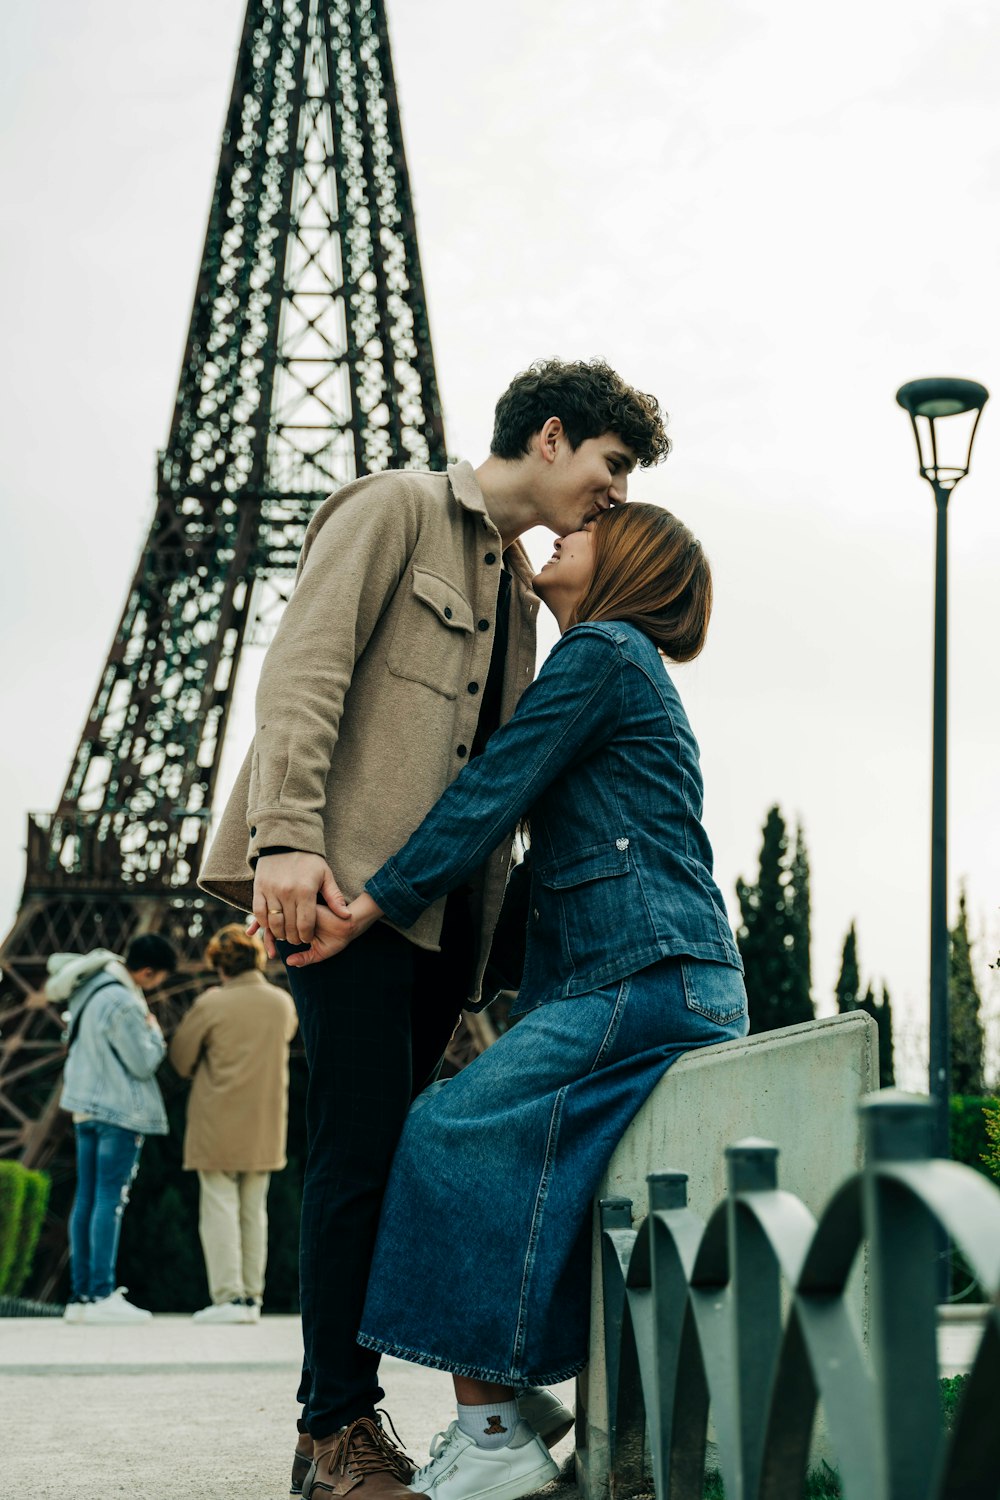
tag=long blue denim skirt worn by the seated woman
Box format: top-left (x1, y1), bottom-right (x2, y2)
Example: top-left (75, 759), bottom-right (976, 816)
top-left (358, 959), bottom-right (748, 1386)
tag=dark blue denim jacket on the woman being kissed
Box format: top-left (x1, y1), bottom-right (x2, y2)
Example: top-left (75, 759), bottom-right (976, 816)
top-left (366, 621), bottom-right (742, 1011)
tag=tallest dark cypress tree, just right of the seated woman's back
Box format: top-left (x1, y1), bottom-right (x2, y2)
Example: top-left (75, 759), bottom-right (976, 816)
top-left (736, 807), bottom-right (814, 1032)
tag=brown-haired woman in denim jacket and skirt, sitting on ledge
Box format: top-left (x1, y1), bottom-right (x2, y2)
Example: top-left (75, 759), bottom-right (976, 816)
top-left (271, 504), bottom-right (747, 1500)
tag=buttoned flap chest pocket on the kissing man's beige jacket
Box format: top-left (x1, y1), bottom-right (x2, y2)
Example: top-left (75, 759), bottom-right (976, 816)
top-left (385, 567), bottom-right (472, 698)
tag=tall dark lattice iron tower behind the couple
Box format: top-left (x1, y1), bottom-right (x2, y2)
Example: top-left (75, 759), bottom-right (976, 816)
top-left (0, 0), bottom-right (491, 1194)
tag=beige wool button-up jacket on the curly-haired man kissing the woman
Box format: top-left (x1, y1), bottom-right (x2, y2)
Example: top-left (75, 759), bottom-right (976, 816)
top-left (199, 464), bottom-right (538, 1002)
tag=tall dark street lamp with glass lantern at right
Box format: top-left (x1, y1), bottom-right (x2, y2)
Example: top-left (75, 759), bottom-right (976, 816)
top-left (897, 377), bottom-right (990, 1157)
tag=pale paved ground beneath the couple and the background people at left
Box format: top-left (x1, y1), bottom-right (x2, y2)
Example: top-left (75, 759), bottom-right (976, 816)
top-left (0, 1316), bottom-right (573, 1500)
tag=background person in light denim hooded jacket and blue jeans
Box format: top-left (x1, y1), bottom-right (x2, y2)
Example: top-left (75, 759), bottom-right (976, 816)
top-left (45, 933), bottom-right (177, 1323)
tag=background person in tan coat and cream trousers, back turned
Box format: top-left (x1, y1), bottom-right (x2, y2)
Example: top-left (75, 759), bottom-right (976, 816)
top-left (169, 923), bottom-right (298, 1323)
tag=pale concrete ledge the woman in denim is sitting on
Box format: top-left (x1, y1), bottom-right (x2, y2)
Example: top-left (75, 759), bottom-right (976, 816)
top-left (577, 1011), bottom-right (879, 1500)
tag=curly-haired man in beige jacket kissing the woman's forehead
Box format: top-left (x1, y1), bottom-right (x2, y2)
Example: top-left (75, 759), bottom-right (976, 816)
top-left (201, 360), bottom-right (670, 1500)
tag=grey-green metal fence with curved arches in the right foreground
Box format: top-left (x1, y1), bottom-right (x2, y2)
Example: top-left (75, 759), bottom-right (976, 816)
top-left (601, 1091), bottom-right (1000, 1500)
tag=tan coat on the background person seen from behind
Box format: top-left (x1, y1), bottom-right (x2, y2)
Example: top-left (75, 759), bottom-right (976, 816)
top-left (169, 969), bottom-right (298, 1172)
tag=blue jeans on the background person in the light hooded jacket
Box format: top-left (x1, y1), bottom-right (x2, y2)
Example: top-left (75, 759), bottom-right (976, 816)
top-left (69, 1121), bottom-right (144, 1302)
